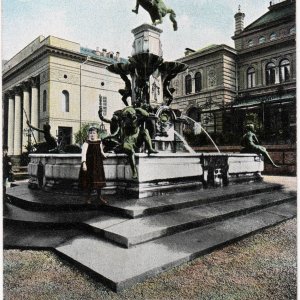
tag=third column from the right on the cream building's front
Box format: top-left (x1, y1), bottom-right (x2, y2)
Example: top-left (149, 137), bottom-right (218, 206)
top-left (14, 88), bottom-right (22, 155)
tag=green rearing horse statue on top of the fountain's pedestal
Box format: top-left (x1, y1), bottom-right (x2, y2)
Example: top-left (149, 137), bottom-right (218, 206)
top-left (132, 0), bottom-right (177, 31)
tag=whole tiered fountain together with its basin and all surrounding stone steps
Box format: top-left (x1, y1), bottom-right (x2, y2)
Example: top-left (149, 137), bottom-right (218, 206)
top-left (4, 0), bottom-right (295, 291)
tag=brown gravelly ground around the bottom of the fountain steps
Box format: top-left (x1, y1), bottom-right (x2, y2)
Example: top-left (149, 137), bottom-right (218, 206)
top-left (3, 176), bottom-right (297, 300)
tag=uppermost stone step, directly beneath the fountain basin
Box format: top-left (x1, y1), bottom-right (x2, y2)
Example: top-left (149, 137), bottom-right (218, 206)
top-left (7, 182), bottom-right (281, 214)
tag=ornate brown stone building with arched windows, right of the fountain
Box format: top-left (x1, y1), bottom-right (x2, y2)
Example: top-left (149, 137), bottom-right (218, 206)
top-left (173, 0), bottom-right (296, 144)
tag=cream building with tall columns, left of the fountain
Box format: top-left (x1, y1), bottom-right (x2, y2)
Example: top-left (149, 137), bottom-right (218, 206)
top-left (2, 36), bottom-right (125, 157)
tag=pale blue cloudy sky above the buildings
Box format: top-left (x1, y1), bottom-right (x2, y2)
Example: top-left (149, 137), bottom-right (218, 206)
top-left (1, 0), bottom-right (269, 60)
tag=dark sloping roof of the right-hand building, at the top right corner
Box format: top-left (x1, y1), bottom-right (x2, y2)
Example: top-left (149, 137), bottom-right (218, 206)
top-left (243, 0), bottom-right (296, 32)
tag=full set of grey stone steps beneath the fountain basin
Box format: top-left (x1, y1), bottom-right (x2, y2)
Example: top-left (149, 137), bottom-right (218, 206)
top-left (4, 182), bottom-right (296, 291)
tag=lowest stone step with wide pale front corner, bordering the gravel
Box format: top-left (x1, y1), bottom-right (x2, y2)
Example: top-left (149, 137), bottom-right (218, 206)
top-left (55, 202), bottom-right (296, 291)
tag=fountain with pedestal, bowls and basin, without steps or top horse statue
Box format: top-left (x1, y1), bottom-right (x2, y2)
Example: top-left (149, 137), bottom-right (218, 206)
top-left (28, 24), bottom-right (263, 198)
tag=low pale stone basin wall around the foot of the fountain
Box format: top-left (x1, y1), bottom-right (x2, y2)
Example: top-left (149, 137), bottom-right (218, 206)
top-left (28, 153), bottom-right (263, 198)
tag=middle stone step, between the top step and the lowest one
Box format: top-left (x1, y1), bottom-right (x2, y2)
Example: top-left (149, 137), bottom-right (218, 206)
top-left (85, 191), bottom-right (295, 248)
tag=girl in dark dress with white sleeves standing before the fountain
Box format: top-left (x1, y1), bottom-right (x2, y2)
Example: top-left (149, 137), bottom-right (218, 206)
top-left (79, 126), bottom-right (107, 204)
